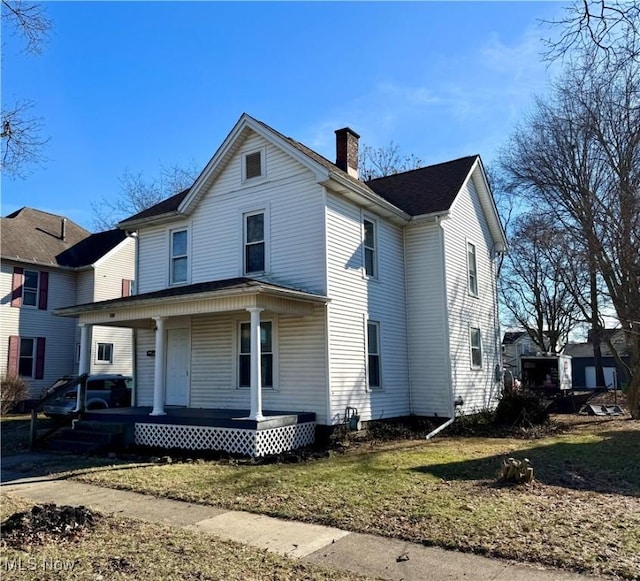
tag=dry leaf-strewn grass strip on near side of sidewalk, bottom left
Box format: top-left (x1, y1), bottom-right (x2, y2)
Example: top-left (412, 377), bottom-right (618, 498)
top-left (0, 495), bottom-right (378, 581)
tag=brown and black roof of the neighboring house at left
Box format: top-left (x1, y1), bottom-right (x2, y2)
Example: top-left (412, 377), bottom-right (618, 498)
top-left (0, 207), bottom-right (126, 268)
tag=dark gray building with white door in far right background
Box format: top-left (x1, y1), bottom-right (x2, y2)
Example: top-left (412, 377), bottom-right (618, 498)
top-left (565, 329), bottom-right (629, 389)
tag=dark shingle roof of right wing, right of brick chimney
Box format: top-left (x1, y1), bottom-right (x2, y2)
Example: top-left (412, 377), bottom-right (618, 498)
top-left (365, 155), bottom-right (478, 216)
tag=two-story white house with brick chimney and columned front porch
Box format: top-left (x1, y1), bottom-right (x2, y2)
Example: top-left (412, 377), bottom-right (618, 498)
top-left (57, 114), bottom-right (506, 447)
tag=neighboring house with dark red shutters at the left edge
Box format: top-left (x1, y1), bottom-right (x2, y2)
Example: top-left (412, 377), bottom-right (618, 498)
top-left (0, 208), bottom-right (135, 398)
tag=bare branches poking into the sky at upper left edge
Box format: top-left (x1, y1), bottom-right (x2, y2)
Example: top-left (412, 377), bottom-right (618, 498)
top-left (0, 0), bottom-right (51, 177)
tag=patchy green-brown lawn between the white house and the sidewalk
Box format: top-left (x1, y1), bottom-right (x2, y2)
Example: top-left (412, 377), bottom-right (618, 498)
top-left (66, 418), bottom-right (640, 579)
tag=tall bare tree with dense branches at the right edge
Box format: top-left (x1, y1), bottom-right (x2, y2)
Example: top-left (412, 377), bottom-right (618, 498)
top-left (501, 60), bottom-right (640, 419)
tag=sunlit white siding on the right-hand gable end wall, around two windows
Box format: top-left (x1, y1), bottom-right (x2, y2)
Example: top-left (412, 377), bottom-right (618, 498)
top-left (443, 179), bottom-right (501, 412)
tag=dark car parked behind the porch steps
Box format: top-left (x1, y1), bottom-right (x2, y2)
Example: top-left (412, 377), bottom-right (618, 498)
top-left (42, 373), bottom-right (133, 418)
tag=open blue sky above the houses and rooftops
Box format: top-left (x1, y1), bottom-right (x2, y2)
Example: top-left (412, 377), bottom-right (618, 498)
top-left (2, 2), bottom-right (563, 229)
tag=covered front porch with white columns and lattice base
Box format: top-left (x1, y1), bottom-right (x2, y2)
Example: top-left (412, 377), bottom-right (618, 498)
top-left (56, 278), bottom-right (328, 456)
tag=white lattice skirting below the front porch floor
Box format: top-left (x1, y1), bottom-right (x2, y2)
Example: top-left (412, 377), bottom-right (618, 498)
top-left (135, 422), bottom-right (316, 457)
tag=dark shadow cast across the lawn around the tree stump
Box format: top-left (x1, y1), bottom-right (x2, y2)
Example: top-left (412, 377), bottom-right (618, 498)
top-left (412, 430), bottom-right (640, 496)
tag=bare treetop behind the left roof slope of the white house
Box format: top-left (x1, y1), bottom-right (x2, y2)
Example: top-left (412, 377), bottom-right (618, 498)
top-left (91, 163), bottom-right (199, 231)
